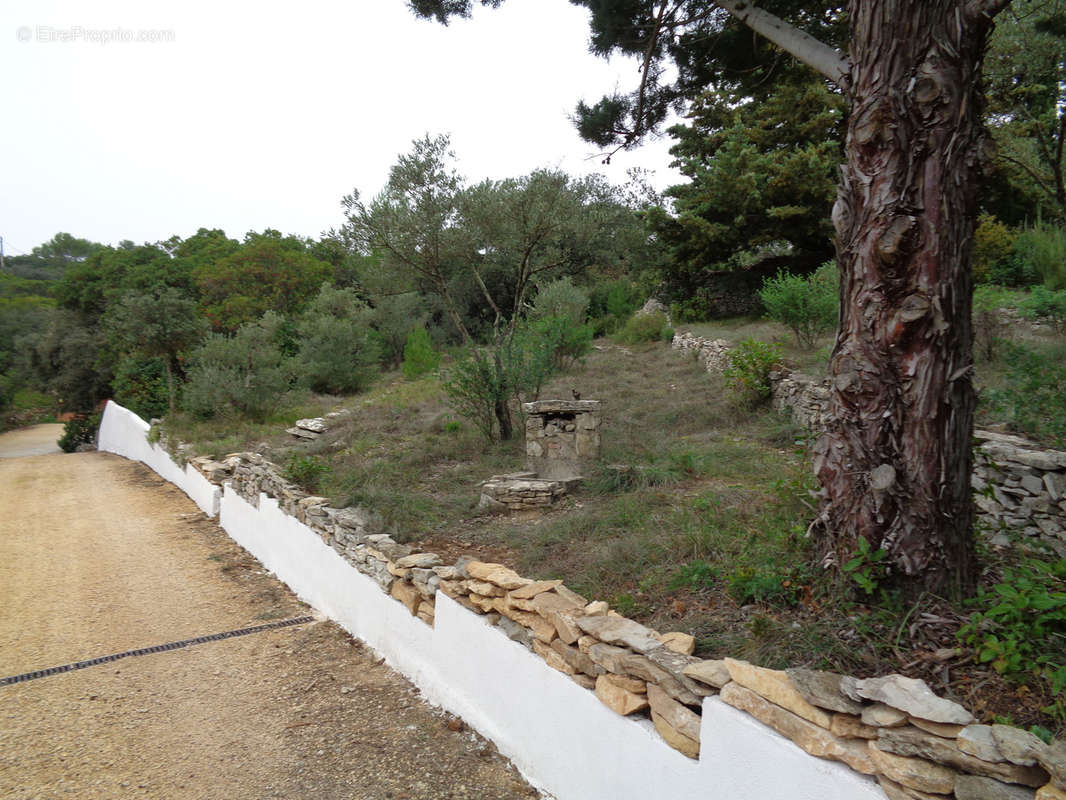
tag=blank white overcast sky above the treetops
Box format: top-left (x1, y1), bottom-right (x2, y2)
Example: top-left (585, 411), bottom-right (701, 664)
top-left (0, 0), bottom-right (678, 254)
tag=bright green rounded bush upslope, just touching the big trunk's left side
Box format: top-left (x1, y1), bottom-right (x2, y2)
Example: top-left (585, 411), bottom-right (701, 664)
top-left (759, 261), bottom-right (840, 350)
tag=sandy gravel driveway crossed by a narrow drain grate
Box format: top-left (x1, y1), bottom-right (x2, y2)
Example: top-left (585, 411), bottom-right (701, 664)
top-left (0, 445), bottom-right (536, 800)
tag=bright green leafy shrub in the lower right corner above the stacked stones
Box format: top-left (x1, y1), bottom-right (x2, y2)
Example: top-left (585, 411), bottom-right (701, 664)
top-left (958, 559), bottom-right (1066, 721)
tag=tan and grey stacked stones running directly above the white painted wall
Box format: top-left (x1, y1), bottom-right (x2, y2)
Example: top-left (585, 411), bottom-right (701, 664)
top-left (164, 407), bottom-right (1066, 800)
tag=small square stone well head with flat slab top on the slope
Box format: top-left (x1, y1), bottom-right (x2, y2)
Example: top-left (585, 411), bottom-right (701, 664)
top-left (522, 400), bottom-right (600, 480)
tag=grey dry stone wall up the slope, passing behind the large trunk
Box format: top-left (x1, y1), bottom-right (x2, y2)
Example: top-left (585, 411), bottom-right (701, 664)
top-left (674, 333), bottom-right (1066, 558)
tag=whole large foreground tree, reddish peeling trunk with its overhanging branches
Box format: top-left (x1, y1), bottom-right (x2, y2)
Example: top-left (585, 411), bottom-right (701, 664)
top-left (411, 0), bottom-right (1010, 594)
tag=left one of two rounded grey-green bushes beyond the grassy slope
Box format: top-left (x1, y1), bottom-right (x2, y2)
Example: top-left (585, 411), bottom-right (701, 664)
top-left (183, 311), bottom-right (297, 421)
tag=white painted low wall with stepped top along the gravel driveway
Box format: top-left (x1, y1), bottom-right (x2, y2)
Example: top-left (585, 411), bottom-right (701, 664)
top-left (100, 403), bottom-right (885, 800)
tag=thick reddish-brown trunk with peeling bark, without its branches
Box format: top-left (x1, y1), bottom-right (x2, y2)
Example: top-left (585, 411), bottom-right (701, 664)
top-left (814, 0), bottom-right (991, 596)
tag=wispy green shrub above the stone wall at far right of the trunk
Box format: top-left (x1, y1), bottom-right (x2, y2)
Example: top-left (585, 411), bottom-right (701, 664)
top-left (988, 345), bottom-right (1066, 447)
